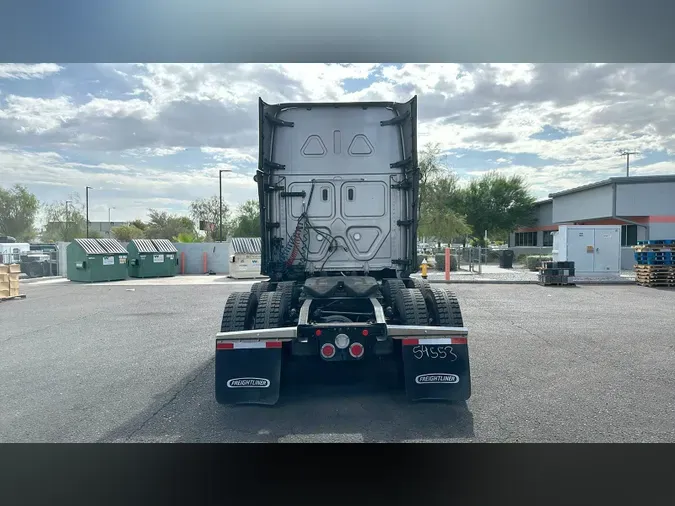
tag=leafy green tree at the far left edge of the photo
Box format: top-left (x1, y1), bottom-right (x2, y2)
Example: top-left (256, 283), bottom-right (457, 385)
top-left (0, 184), bottom-right (40, 242)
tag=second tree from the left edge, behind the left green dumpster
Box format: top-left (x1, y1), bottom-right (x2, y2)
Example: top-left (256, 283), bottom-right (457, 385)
top-left (42, 193), bottom-right (88, 242)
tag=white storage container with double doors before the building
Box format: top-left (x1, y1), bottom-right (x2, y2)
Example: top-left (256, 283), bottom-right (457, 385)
top-left (552, 225), bottom-right (621, 276)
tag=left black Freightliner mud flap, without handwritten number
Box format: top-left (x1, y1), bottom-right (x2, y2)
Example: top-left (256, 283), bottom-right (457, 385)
top-left (216, 341), bottom-right (281, 405)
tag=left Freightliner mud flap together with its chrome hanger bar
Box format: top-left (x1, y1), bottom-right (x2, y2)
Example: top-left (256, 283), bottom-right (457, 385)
top-left (215, 327), bottom-right (296, 405)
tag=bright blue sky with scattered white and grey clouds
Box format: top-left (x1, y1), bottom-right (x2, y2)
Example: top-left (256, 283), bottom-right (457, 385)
top-left (0, 63), bottom-right (675, 221)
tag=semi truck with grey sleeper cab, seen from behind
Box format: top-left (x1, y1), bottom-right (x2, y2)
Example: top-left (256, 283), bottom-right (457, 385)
top-left (215, 96), bottom-right (471, 405)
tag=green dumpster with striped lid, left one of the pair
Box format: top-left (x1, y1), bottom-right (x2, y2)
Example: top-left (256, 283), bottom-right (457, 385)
top-left (66, 239), bottom-right (128, 283)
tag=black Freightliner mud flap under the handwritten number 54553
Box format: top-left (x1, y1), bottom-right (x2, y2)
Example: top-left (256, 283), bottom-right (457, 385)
top-left (402, 337), bottom-right (471, 401)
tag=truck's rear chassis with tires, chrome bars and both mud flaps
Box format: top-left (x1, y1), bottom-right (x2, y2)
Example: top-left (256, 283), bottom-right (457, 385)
top-left (215, 276), bottom-right (471, 405)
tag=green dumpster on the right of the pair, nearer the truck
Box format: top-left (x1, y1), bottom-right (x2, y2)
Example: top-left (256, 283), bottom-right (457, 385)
top-left (127, 239), bottom-right (178, 278)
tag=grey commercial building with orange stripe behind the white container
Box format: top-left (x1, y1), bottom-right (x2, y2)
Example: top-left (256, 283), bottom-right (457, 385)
top-left (509, 175), bottom-right (675, 269)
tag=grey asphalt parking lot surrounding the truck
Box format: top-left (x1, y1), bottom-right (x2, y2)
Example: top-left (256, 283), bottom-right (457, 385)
top-left (0, 280), bottom-right (675, 442)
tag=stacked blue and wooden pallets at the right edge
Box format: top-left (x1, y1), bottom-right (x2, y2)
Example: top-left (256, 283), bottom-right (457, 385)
top-left (634, 239), bottom-right (675, 287)
